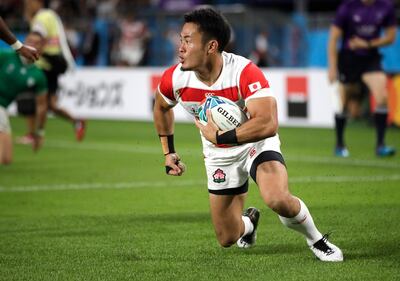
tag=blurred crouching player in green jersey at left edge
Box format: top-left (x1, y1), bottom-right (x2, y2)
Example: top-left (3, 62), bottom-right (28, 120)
top-left (0, 33), bottom-right (47, 164)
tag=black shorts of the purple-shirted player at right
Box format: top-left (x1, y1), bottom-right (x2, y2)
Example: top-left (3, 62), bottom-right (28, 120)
top-left (338, 50), bottom-right (383, 84)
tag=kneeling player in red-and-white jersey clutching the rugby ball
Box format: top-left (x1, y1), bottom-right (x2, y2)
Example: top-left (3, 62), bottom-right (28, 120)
top-left (154, 8), bottom-right (343, 262)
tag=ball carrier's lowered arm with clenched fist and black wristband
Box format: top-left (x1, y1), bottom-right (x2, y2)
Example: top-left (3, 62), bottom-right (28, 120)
top-left (153, 90), bottom-right (185, 176)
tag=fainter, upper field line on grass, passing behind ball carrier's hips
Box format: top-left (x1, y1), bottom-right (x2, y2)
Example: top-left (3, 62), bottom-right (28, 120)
top-left (41, 140), bottom-right (400, 170)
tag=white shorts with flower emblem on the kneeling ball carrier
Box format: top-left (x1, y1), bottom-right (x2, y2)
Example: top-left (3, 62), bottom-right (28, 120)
top-left (204, 135), bottom-right (285, 195)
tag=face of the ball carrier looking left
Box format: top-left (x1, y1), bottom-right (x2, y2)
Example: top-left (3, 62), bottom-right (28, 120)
top-left (179, 22), bottom-right (207, 70)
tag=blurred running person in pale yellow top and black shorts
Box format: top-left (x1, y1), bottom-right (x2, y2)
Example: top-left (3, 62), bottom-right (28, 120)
top-left (20, 0), bottom-right (86, 143)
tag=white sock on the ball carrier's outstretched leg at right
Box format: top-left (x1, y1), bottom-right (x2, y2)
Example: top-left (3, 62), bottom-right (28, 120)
top-left (279, 198), bottom-right (322, 246)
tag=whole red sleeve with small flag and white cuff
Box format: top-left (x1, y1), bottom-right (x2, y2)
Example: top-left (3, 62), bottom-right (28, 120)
top-left (239, 62), bottom-right (273, 103)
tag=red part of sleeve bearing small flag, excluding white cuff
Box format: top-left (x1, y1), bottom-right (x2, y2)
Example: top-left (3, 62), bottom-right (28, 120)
top-left (240, 62), bottom-right (269, 99)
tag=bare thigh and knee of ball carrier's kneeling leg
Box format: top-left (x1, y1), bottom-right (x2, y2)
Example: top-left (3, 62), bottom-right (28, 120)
top-left (209, 193), bottom-right (247, 236)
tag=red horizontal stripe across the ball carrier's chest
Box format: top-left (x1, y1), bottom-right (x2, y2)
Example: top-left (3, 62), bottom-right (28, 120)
top-left (179, 87), bottom-right (239, 102)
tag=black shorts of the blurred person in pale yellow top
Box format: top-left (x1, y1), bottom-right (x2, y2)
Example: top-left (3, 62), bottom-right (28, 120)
top-left (43, 54), bottom-right (67, 95)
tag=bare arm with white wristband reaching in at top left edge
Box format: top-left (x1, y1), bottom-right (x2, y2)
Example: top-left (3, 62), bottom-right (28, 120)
top-left (0, 16), bottom-right (39, 61)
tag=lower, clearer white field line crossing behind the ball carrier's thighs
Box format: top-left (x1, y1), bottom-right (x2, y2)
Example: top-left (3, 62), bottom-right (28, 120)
top-left (0, 174), bottom-right (400, 193)
